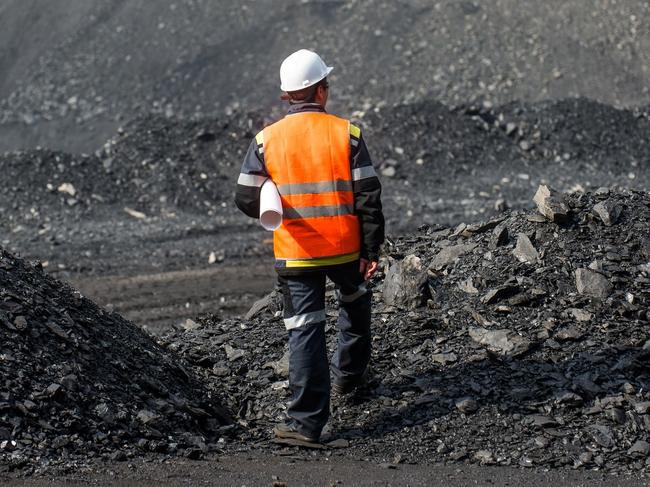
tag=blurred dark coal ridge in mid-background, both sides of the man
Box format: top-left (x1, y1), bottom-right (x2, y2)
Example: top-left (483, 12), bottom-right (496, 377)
top-left (0, 99), bottom-right (650, 237)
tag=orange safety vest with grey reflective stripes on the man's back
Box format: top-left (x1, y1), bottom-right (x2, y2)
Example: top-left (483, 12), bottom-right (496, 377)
top-left (257, 112), bottom-right (361, 268)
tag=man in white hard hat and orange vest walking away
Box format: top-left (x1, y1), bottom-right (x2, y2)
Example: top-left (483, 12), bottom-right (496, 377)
top-left (235, 49), bottom-right (384, 443)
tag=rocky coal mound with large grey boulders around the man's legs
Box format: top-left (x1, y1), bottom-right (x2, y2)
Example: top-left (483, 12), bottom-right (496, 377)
top-left (163, 188), bottom-right (650, 472)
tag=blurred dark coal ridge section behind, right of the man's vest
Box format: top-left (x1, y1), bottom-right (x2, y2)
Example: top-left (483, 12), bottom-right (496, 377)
top-left (356, 99), bottom-right (650, 233)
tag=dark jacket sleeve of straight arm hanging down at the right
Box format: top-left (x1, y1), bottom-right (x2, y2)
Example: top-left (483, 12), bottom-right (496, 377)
top-left (350, 129), bottom-right (385, 260)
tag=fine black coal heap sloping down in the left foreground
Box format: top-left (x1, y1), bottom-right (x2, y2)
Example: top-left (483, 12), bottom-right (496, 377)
top-left (0, 249), bottom-right (229, 469)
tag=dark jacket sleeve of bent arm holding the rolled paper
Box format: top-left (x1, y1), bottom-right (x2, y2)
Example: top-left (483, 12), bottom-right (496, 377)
top-left (235, 134), bottom-right (269, 218)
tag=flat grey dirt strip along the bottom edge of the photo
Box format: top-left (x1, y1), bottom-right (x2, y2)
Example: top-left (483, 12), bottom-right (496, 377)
top-left (0, 450), bottom-right (648, 487)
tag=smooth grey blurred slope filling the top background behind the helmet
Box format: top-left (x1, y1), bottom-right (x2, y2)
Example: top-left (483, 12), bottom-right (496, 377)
top-left (0, 0), bottom-right (650, 151)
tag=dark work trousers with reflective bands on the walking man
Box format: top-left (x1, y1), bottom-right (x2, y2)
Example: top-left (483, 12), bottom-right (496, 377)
top-left (279, 261), bottom-right (372, 437)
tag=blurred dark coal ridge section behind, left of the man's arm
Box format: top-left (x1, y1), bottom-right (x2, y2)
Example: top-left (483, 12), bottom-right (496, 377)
top-left (0, 114), bottom-right (259, 219)
